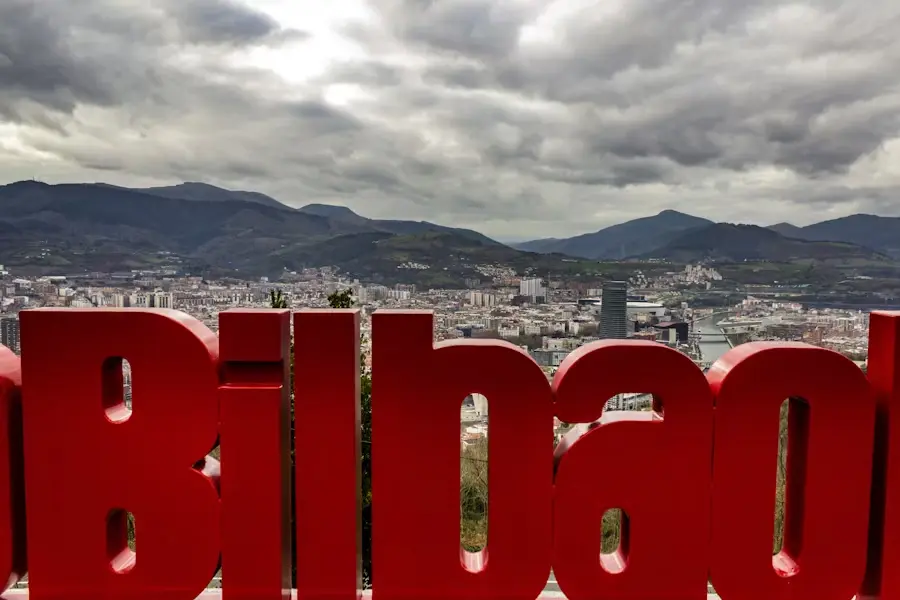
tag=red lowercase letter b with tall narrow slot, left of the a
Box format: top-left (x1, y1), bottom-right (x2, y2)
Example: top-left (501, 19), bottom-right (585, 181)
top-left (372, 311), bottom-right (553, 600)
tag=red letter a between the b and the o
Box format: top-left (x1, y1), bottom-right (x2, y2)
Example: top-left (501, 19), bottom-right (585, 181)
top-left (553, 341), bottom-right (713, 600)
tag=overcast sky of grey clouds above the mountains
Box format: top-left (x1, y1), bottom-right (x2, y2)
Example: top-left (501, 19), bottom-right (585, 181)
top-left (0, 0), bottom-right (900, 239)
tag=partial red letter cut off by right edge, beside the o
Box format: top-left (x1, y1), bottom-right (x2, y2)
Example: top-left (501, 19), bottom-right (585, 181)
top-left (860, 312), bottom-right (900, 600)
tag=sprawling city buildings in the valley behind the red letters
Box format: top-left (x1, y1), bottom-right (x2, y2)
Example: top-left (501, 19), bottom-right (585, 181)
top-left (0, 265), bottom-right (869, 432)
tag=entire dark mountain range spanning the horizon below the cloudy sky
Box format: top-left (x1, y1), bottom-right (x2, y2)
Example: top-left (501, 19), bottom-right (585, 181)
top-left (0, 181), bottom-right (900, 286)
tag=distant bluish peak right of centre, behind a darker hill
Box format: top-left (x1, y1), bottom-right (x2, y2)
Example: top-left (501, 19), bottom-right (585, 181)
top-left (513, 210), bottom-right (712, 260)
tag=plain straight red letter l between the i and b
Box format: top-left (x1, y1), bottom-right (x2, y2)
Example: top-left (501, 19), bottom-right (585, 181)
top-left (294, 310), bottom-right (368, 600)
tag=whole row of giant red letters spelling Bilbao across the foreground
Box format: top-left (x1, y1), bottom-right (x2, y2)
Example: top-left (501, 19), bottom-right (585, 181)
top-left (0, 309), bottom-right (900, 600)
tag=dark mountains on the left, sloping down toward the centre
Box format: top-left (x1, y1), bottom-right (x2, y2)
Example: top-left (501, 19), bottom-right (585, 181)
top-left (0, 181), bottom-right (573, 285)
